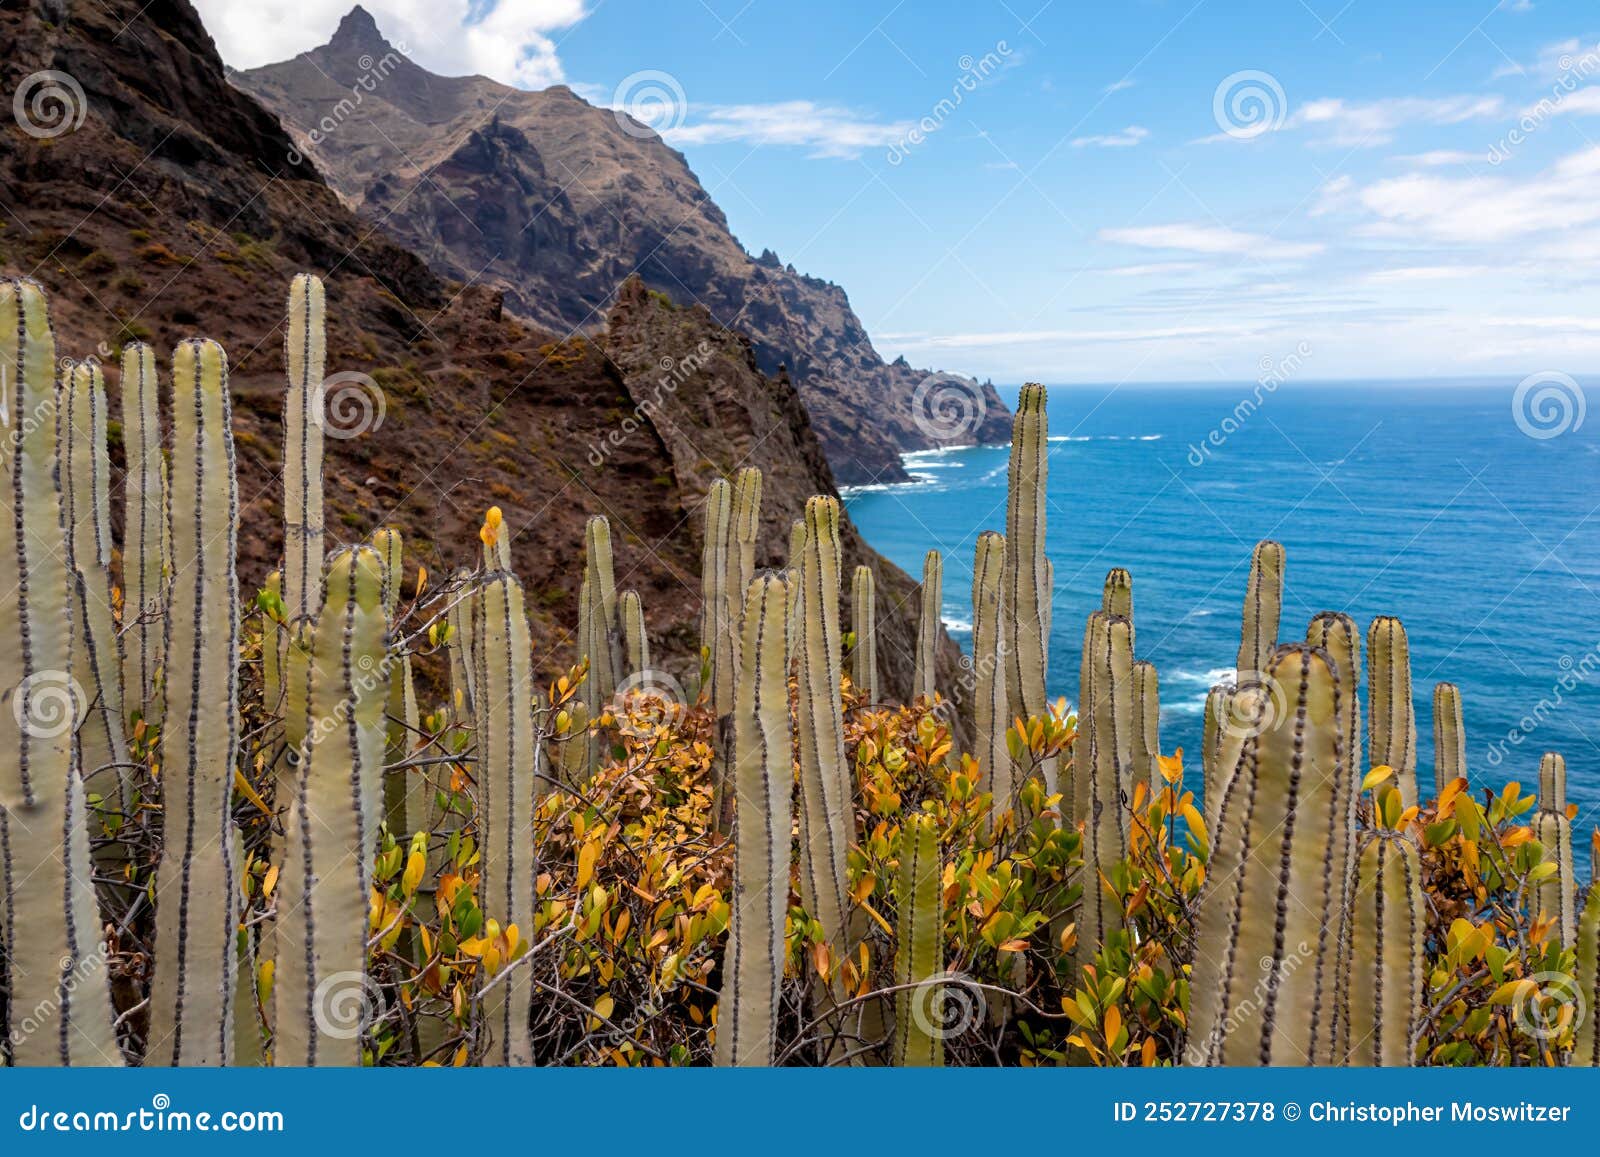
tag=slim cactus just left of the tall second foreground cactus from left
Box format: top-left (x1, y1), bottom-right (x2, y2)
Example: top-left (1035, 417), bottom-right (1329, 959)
top-left (122, 342), bottom-right (165, 727)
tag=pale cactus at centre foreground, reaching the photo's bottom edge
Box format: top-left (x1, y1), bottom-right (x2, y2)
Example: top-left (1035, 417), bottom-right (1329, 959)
top-left (717, 576), bottom-right (794, 1066)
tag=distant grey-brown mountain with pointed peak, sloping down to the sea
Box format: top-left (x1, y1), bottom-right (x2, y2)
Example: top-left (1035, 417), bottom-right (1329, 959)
top-left (232, 8), bottom-right (1010, 483)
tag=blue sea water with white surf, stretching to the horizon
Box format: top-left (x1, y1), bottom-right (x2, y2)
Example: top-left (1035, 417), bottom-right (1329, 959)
top-left (846, 379), bottom-right (1600, 856)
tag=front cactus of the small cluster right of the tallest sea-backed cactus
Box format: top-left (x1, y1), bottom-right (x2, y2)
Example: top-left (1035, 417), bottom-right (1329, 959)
top-left (1072, 611), bottom-right (1134, 967)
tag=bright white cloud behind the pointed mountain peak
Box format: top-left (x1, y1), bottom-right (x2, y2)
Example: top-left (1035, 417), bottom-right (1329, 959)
top-left (195, 0), bottom-right (586, 88)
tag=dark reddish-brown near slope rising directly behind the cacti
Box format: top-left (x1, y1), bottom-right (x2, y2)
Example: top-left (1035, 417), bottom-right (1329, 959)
top-left (0, 0), bottom-right (960, 723)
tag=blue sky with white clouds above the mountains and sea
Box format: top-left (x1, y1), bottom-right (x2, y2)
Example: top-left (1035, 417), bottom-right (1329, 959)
top-left (197, 0), bottom-right (1600, 382)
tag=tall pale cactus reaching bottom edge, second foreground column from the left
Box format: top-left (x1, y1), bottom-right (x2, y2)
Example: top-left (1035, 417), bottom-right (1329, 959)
top-left (146, 341), bottom-right (240, 1066)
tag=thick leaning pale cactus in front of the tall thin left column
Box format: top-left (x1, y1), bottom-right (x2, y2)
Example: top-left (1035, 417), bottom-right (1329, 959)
top-left (272, 546), bottom-right (389, 1066)
